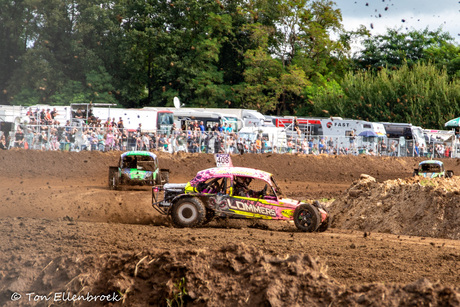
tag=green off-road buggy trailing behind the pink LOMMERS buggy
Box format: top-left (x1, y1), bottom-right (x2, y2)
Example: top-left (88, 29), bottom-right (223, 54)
top-left (109, 151), bottom-right (169, 190)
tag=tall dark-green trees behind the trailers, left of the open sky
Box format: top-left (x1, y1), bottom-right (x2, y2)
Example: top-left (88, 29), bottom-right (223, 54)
top-left (0, 0), bottom-right (356, 113)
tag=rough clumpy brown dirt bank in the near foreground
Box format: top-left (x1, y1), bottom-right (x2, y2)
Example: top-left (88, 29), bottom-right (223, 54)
top-left (0, 244), bottom-right (460, 306)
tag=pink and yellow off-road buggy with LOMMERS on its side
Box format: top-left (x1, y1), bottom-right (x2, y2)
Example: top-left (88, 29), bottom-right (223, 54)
top-left (152, 167), bottom-right (331, 232)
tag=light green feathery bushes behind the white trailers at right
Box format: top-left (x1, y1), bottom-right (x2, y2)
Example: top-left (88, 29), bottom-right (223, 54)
top-left (313, 63), bottom-right (460, 129)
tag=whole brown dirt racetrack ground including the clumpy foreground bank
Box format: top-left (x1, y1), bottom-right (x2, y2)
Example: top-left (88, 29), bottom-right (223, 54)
top-left (0, 150), bottom-right (460, 306)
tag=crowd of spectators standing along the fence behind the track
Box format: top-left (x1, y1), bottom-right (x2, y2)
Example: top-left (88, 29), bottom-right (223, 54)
top-left (0, 109), bottom-right (452, 158)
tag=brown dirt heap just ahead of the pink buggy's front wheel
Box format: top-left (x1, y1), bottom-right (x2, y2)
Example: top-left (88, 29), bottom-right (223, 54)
top-left (330, 175), bottom-right (460, 240)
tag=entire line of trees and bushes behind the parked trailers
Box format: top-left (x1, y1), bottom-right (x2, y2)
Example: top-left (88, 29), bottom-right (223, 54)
top-left (0, 0), bottom-right (460, 128)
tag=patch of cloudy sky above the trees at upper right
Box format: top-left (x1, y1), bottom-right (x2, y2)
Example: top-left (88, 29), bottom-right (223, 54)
top-left (333, 0), bottom-right (460, 48)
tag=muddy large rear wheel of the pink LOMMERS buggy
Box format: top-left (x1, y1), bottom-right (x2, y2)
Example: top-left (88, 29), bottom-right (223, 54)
top-left (171, 197), bottom-right (206, 227)
